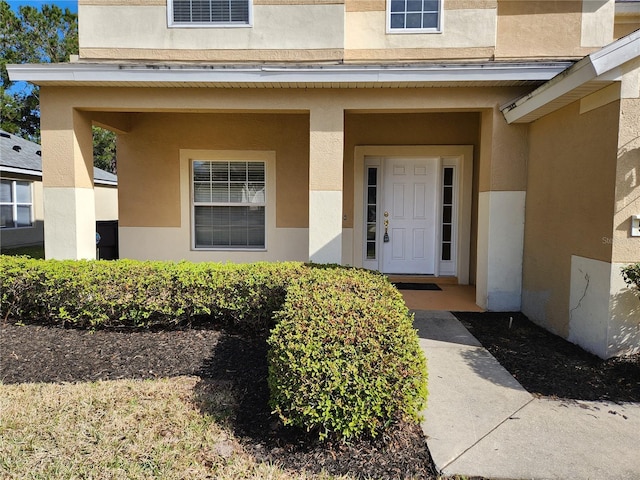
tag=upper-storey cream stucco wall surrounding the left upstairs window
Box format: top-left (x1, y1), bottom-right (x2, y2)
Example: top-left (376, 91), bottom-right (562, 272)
top-left (78, 1), bottom-right (344, 62)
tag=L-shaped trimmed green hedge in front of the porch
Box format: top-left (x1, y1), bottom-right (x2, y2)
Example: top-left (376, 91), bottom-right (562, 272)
top-left (0, 256), bottom-right (427, 439)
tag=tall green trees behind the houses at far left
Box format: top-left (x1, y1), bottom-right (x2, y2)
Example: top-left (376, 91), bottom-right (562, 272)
top-left (0, 0), bottom-right (115, 171)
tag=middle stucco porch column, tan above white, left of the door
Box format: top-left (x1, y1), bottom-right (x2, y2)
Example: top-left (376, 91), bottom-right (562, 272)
top-left (309, 105), bottom-right (344, 263)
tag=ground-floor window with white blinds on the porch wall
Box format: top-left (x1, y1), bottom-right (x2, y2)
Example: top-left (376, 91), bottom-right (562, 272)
top-left (191, 160), bottom-right (266, 249)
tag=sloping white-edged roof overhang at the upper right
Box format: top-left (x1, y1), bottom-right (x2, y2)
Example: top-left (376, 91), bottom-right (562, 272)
top-left (501, 30), bottom-right (640, 123)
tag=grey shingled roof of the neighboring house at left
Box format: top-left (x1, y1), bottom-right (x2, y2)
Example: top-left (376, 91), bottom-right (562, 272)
top-left (0, 130), bottom-right (118, 185)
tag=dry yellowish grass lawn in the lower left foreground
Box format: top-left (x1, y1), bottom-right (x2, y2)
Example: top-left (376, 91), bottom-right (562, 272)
top-left (0, 377), bottom-right (350, 480)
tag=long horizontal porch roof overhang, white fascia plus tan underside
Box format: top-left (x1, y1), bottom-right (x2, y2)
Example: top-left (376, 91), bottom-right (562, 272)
top-left (7, 61), bottom-right (573, 88)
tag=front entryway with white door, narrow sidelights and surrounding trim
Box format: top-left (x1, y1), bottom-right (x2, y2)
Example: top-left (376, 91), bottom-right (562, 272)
top-left (354, 146), bottom-right (473, 284)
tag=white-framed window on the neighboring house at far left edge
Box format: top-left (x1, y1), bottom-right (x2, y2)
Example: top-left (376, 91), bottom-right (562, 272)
top-left (0, 178), bottom-right (33, 228)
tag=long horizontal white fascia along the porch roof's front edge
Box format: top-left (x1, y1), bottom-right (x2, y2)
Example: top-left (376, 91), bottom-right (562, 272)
top-left (7, 62), bottom-right (571, 85)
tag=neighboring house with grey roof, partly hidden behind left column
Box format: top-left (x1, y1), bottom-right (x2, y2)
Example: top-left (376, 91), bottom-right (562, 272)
top-left (0, 130), bottom-right (118, 249)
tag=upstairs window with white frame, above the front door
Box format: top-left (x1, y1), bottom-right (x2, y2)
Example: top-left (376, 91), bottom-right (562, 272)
top-left (387, 0), bottom-right (442, 33)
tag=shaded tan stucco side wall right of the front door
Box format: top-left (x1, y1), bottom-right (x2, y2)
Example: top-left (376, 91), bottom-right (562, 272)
top-left (523, 101), bottom-right (620, 337)
